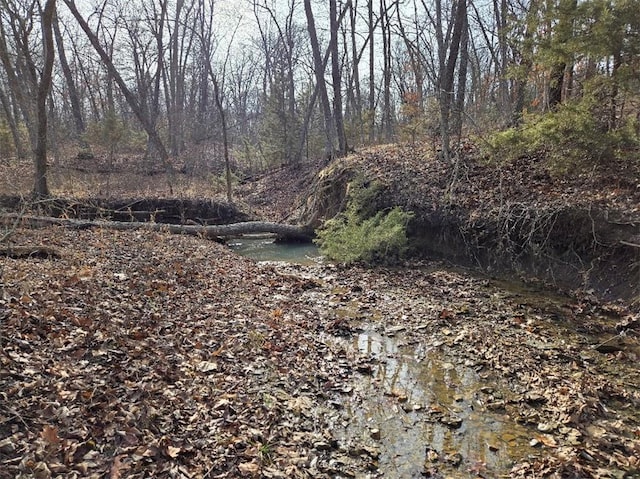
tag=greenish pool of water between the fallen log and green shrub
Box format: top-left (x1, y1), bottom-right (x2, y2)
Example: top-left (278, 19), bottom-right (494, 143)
top-left (227, 237), bottom-right (321, 265)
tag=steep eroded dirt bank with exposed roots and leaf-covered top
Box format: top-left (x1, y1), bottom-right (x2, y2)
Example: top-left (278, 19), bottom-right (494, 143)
top-left (292, 145), bottom-right (640, 309)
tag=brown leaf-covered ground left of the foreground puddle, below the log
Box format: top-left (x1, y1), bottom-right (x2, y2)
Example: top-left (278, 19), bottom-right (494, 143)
top-left (0, 228), bottom-right (340, 478)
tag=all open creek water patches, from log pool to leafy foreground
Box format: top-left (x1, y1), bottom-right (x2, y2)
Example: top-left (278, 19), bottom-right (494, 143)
top-left (230, 239), bottom-right (636, 479)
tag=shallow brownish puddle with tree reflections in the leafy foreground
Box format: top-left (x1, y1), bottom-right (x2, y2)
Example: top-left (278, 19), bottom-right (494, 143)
top-left (324, 331), bottom-right (539, 478)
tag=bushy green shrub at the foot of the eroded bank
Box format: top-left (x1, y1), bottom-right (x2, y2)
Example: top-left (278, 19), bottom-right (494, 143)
top-left (316, 179), bottom-right (413, 265)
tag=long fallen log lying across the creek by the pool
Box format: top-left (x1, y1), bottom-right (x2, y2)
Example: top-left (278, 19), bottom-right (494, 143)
top-left (0, 214), bottom-right (314, 241)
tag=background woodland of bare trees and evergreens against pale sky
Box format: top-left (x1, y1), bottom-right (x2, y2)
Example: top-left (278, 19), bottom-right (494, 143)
top-left (0, 0), bottom-right (640, 199)
